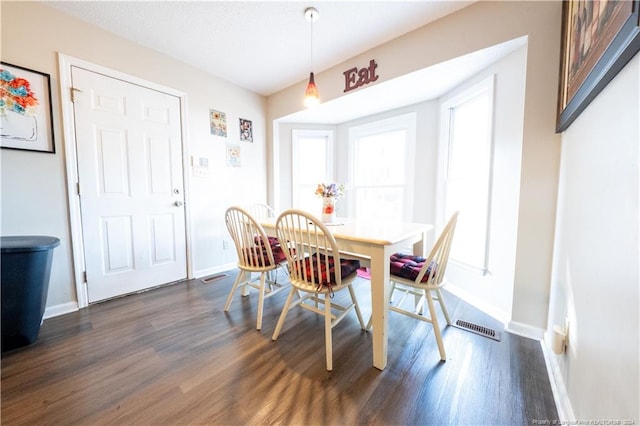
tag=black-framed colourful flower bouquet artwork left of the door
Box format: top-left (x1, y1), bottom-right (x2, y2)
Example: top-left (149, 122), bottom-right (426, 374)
top-left (0, 62), bottom-right (55, 153)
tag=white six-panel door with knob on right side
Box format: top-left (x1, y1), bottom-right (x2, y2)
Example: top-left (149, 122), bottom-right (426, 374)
top-left (72, 66), bottom-right (187, 302)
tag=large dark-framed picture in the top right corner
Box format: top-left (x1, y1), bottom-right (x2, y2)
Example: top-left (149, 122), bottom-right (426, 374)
top-left (556, 0), bottom-right (640, 133)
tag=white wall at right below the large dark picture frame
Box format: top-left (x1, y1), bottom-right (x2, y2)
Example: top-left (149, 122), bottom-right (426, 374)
top-left (546, 55), bottom-right (640, 424)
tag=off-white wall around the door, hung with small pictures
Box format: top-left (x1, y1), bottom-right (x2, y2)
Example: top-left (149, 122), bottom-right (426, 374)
top-left (0, 2), bottom-right (267, 315)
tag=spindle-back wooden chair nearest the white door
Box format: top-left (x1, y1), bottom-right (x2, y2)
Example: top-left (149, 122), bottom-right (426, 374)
top-left (224, 206), bottom-right (286, 330)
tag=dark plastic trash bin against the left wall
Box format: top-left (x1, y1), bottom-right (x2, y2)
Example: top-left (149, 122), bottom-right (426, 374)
top-left (0, 235), bottom-right (60, 352)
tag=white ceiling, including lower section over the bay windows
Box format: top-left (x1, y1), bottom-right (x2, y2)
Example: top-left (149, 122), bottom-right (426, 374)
top-left (43, 0), bottom-right (524, 123)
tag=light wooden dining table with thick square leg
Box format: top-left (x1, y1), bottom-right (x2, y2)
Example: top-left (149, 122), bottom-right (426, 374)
top-left (259, 218), bottom-right (433, 370)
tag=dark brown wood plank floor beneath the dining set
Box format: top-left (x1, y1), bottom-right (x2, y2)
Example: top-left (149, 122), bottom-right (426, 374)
top-left (1, 271), bottom-right (557, 425)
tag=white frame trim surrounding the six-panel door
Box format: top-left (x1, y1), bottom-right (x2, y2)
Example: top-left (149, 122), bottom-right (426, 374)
top-left (58, 53), bottom-right (193, 308)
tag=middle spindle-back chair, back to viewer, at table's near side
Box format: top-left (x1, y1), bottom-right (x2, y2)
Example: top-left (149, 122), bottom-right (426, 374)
top-left (272, 210), bottom-right (365, 371)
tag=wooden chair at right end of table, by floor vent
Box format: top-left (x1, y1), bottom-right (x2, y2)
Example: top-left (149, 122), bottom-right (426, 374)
top-left (367, 212), bottom-right (459, 361)
